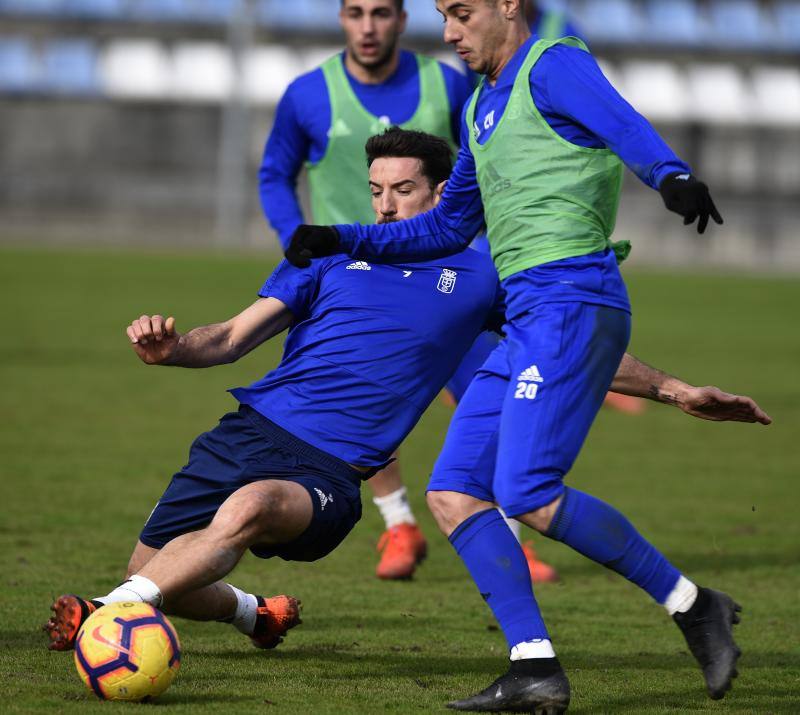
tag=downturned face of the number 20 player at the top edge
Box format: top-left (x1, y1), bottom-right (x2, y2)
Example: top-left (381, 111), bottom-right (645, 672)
top-left (436, 0), bottom-right (521, 74)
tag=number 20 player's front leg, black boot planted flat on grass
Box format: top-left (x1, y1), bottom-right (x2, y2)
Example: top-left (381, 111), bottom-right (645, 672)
top-left (428, 343), bottom-right (570, 713)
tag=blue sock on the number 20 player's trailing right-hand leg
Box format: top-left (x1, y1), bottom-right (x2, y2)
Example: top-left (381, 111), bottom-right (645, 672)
top-left (545, 488), bottom-right (681, 604)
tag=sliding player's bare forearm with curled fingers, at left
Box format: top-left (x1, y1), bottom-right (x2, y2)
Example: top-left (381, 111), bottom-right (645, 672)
top-left (126, 298), bottom-right (292, 367)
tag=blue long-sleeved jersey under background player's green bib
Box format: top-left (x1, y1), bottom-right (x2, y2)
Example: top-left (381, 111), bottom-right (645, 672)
top-left (259, 51), bottom-right (472, 246)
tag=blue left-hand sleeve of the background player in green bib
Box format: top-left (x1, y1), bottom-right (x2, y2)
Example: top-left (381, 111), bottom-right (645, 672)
top-left (258, 85), bottom-right (310, 248)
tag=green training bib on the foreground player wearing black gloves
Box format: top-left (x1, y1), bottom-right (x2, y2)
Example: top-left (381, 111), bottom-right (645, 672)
top-left (467, 37), bottom-right (629, 279)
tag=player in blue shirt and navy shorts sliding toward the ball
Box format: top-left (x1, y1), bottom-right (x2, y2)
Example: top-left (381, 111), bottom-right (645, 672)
top-left (46, 132), bottom-right (762, 692)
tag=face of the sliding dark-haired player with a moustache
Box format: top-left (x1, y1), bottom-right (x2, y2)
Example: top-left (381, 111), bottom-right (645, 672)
top-left (369, 157), bottom-right (445, 223)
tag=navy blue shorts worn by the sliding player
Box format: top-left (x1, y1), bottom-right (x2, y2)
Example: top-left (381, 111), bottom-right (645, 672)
top-left (139, 405), bottom-right (361, 561)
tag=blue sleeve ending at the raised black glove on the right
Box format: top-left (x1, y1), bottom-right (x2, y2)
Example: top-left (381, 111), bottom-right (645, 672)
top-left (530, 45), bottom-right (691, 189)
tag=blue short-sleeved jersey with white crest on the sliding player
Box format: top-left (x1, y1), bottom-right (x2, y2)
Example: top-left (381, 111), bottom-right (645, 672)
top-left (231, 250), bottom-right (504, 467)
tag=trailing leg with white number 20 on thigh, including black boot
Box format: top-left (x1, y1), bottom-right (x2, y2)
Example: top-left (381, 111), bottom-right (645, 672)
top-left (494, 303), bottom-right (739, 698)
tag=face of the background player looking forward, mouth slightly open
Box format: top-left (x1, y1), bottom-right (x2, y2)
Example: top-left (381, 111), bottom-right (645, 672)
top-left (339, 0), bottom-right (406, 69)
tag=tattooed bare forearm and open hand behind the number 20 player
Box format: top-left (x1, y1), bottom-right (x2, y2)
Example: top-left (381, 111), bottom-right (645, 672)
top-left (611, 353), bottom-right (772, 425)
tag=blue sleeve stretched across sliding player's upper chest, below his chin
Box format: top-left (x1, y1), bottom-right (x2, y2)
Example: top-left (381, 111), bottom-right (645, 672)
top-left (336, 110), bottom-right (484, 263)
